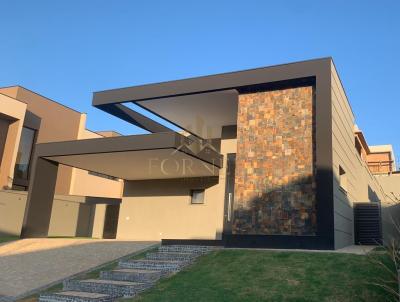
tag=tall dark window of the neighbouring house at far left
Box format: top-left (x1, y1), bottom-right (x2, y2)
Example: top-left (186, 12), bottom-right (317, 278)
top-left (14, 127), bottom-right (36, 180)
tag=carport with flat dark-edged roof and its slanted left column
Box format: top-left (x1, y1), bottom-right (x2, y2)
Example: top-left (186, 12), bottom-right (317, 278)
top-left (21, 131), bottom-right (222, 238)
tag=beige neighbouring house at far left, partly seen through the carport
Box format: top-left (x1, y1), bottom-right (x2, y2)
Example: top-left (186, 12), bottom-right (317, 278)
top-left (0, 86), bottom-right (123, 237)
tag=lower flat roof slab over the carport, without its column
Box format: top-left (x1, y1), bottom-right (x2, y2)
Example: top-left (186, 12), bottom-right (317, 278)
top-left (35, 132), bottom-right (222, 180)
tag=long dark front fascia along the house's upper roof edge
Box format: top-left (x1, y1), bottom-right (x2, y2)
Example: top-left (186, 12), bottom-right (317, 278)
top-left (92, 57), bottom-right (332, 107)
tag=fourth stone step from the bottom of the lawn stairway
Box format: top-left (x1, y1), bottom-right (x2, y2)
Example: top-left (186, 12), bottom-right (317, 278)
top-left (119, 259), bottom-right (188, 273)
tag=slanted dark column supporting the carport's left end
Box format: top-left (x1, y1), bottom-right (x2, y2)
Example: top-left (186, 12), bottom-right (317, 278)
top-left (21, 157), bottom-right (58, 238)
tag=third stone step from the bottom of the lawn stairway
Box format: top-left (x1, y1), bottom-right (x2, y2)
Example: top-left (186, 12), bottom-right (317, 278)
top-left (100, 268), bottom-right (162, 283)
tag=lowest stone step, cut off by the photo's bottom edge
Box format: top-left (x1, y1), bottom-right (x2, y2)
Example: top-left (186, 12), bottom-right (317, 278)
top-left (39, 291), bottom-right (115, 302)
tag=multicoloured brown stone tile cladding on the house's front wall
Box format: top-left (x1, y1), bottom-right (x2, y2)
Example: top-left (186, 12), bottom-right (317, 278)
top-left (232, 87), bottom-right (317, 235)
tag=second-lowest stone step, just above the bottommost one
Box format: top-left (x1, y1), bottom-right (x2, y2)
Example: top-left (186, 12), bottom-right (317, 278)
top-left (64, 279), bottom-right (152, 297)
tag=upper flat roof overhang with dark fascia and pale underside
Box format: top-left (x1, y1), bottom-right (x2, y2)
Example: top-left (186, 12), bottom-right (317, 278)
top-left (92, 58), bottom-right (332, 139)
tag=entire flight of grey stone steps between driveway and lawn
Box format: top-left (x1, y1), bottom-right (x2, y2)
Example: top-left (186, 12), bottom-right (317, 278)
top-left (39, 245), bottom-right (216, 302)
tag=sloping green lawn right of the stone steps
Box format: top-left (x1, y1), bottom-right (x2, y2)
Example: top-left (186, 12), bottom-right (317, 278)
top-left (131, 250), bottom-right (393, 302)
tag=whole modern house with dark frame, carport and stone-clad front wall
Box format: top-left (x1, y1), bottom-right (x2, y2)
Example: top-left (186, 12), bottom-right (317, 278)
top-left (3, 58), bottom-right (395, 249)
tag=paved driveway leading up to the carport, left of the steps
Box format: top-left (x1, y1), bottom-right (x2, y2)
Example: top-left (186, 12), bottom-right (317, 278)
top-left (0, 238), bottom-right (157, 300)
